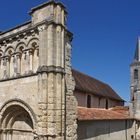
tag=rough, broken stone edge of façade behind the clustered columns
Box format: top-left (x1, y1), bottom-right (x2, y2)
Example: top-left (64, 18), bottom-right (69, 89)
top-left (65, 35), bottom-right (77, 140)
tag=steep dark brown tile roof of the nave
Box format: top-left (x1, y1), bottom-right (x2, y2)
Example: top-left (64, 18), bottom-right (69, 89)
top-left (72, 69), bottom-right (124, 101)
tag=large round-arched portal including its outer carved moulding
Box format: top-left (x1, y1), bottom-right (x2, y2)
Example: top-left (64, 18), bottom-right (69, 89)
top-left (0, 99), bottom-right (36, 140)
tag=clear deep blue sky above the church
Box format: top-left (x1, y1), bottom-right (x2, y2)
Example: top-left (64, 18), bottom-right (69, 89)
top-left (0, 0), bottom-right (140, 101)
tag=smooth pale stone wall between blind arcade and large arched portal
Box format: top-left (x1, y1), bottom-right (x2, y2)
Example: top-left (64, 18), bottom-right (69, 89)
top-left (0, 76), bottom-right (38, 110)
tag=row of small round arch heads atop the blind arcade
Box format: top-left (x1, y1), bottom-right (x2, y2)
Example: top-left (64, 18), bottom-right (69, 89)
top-left (0, 38), bottom-right (39, 57)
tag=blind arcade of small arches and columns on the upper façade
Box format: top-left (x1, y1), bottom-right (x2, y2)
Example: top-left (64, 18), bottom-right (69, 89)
top-left (0, 38), bottom-right (39, 79)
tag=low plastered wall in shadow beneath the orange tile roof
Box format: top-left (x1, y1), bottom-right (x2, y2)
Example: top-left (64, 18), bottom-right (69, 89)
top-left (77, 120), bottom-right (136, 140)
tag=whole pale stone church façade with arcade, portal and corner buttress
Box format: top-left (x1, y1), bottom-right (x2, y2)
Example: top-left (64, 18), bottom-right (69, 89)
top-left (0, 1), bottom-right (77, 140)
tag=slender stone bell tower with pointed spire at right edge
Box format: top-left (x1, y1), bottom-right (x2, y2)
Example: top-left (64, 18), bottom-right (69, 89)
top-left (130, 38), bottom-right (140, 118)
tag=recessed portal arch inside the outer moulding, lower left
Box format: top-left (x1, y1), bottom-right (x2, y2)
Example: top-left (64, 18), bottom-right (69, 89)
top-left (0, 100), bottom-right (34, 140)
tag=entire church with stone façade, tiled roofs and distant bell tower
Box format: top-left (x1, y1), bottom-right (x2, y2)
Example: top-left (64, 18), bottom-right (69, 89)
top-left (0, 1), bottom-right (140, 140)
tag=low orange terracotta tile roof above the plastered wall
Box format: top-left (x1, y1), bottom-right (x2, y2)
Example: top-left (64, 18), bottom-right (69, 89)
top-left (77, 107), bottom-right (132, 121)
